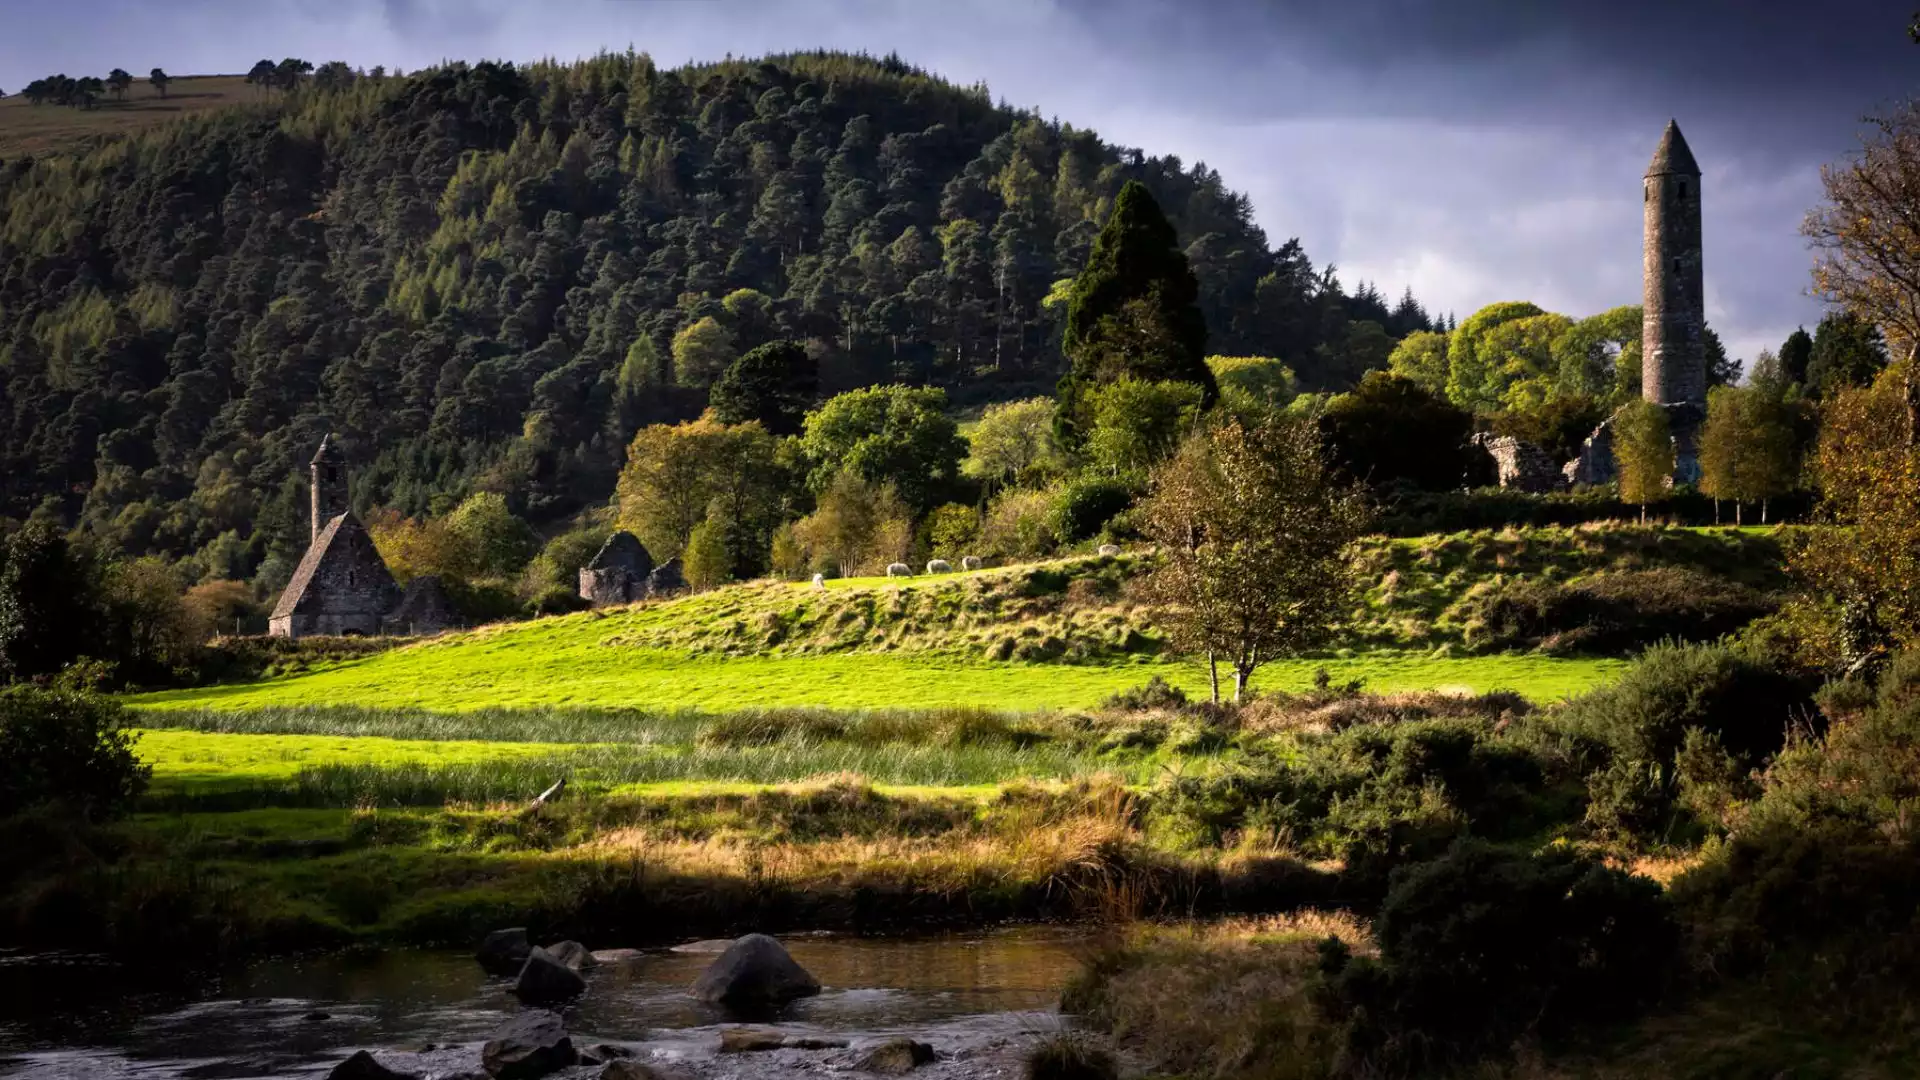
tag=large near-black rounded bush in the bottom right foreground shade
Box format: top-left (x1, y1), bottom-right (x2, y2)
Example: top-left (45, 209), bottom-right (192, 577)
top-left (1321, 842), bottom-right (1680, 1074)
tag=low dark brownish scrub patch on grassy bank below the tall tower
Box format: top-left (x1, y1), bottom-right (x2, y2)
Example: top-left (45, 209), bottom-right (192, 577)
top-left (1463, 567), bottom-right (1778, 653)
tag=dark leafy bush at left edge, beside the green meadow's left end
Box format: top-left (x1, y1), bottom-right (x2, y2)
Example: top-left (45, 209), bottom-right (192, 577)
top-left (0, 686), bottom-right (152, 817)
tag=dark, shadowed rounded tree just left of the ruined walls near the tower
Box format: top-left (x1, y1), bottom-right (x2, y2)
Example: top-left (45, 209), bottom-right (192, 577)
top-left (1319, 371), bottom-right (1484, 490)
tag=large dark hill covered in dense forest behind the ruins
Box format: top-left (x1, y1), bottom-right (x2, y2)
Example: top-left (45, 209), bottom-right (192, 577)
top-left (0, 54), bottom-right (1427, 577)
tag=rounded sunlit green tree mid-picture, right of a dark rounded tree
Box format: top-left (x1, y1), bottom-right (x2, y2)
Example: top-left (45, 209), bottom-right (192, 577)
top-left (801, 386), bottom-right (966, 509)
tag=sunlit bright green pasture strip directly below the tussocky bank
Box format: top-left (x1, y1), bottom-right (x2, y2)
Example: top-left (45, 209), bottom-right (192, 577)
top-left (129, 641), bottom-right (1622, 713)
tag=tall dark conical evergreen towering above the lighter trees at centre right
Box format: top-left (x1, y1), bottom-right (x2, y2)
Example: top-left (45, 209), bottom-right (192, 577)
top-left (1054, 181), bottom-right (1219, 450)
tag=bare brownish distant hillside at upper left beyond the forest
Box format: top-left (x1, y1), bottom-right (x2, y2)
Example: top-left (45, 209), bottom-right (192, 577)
top-left (0, 75), bottom-right (263, 160)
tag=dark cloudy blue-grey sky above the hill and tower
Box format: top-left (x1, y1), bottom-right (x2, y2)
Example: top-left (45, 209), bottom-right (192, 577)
top-left (0, 0), bottom-right (1920, 357)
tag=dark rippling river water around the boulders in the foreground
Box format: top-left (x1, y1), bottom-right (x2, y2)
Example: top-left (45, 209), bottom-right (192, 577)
top-left (0, 928), bottom-right (1083, 1080)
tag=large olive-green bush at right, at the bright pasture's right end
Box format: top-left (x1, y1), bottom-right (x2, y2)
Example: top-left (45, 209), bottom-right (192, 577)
top-left (1551, 644), bottom-right (1811, 842)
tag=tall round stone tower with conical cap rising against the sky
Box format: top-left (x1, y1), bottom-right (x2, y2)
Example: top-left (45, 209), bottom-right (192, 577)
top-left (1640, 121), bottom-right (1707, 407)
